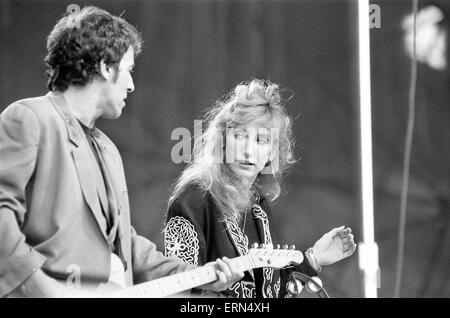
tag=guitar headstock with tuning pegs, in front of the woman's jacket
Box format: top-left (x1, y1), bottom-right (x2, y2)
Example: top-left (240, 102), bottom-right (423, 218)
top-left (248, 243), bottom-right (303, 268)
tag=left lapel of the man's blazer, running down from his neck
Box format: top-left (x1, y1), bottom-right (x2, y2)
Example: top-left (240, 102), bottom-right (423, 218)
top-left (46, 92), bottom-right (108, 241)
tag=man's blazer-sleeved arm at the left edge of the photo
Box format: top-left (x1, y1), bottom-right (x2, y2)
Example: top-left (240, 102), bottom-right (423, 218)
top-left (0, 104), bottom-right (46, 297)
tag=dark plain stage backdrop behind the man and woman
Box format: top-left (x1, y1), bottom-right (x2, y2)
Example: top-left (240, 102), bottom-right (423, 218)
top-left (0, 0), bottom-right (450, 297)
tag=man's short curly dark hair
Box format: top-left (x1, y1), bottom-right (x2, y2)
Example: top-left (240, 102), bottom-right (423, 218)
top-left (44, 6), bottom-right (142, 92)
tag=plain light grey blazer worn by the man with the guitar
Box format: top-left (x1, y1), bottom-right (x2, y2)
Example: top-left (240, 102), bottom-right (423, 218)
top-left (0, 93), bottom-right (191, 296)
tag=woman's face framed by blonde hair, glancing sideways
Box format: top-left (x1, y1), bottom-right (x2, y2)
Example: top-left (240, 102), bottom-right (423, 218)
top-left (225, 126), bottom-right (273, 184)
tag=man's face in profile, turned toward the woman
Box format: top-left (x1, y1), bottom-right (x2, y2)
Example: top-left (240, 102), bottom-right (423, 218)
top-left (102, 46), bottom-right (134, 119)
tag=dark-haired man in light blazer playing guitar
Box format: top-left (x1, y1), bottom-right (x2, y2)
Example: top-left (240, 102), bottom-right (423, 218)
top-left (0, 7), bottom-right (243, 297)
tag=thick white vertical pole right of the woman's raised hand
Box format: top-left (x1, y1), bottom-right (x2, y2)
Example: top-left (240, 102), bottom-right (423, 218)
top-left (358, 0), bottom-right (380, 298)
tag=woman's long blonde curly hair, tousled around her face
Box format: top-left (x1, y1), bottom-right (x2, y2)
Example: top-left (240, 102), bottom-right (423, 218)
top-left (169, 79), bottom-right (295, 220)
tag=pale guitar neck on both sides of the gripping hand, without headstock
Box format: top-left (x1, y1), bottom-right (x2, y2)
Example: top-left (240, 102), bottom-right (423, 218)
top-left (113, 255), bottom-right (254, 298)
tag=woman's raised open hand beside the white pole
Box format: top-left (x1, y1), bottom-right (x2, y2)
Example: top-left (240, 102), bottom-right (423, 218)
top-left (313, 226), bottom-right (356, 266)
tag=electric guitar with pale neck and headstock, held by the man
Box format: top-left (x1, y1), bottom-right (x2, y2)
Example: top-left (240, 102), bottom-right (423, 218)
top-left (105, 246), bottom-right (303, 298)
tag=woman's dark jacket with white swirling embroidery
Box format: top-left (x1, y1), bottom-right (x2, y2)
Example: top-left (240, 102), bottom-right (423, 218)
top-left (164, 184), bottom-right (317, 298)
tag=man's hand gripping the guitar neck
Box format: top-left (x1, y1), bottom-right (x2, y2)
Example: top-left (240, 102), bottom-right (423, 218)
top-left (199, 257), bottom-right (244, 292)
